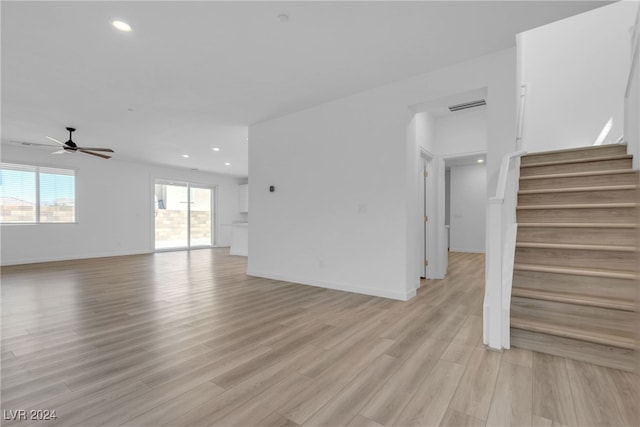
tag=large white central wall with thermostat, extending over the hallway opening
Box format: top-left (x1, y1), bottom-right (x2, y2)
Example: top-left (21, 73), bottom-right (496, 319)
top-left (248, 49), bottom-right (515, 299)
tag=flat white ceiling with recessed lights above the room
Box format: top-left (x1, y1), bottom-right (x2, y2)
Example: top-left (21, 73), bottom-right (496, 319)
top-left (1, 1), bottom-right (606, 176)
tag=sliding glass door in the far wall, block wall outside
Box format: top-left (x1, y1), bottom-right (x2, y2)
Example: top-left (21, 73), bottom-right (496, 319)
top-left (154, 180), bottom-right (215, 250)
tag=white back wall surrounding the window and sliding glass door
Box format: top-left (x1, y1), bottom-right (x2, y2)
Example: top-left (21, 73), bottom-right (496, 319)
top-left (0, 146), bottom-right (244, 265)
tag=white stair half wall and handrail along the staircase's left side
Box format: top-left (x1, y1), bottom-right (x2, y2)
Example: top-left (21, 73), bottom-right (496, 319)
top-left (482, 85), bottom-right (527, 350)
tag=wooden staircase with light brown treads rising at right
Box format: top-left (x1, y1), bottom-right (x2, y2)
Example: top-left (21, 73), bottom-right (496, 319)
top-left (511, 145), bottom-right (639, 371)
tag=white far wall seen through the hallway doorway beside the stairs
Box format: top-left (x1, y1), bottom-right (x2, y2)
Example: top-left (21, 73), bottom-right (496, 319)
top-left (451, 165), bottom-right (487, 252)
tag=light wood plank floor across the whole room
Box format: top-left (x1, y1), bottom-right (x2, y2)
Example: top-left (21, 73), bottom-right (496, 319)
top-left (1, 249), bottom-right (640, 427)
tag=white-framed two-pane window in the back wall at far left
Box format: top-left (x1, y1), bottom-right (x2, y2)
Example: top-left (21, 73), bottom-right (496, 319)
top-left (0, 163), bottom-right (76, 224)
